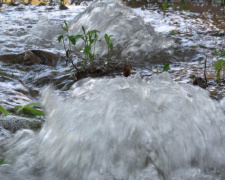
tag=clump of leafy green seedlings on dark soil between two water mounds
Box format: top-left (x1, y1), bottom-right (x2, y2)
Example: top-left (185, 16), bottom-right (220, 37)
top-left (58, 21), bottom-right (121, 79)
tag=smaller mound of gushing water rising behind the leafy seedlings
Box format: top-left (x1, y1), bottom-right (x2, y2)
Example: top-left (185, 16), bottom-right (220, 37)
top-left (70, 1), bottom-right (174, 61)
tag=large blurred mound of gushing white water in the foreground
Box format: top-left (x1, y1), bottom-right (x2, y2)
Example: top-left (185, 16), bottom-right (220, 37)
top-left (0, 73), bottom-right (225, 180)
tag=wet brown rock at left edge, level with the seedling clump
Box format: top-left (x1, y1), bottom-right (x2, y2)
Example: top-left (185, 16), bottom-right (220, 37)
top-left (0, 50), bottom-right (60, 66)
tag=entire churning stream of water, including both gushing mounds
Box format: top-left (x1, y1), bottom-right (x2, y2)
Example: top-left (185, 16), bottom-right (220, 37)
top-left (0, 1), bottom-right (225, 180)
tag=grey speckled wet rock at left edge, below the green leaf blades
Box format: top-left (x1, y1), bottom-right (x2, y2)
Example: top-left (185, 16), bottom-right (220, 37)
top-left (0, 115), bottom-right (44, 133)
